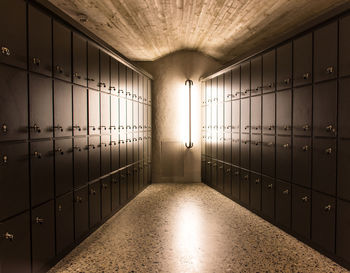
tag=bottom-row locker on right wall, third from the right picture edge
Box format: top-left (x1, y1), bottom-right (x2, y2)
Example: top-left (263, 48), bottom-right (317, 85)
top-left (292, 185), bottom-right (311, 239)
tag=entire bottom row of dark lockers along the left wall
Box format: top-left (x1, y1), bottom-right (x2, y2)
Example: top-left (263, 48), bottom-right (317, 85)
top-left (0, 162), bottom-right (150, 273)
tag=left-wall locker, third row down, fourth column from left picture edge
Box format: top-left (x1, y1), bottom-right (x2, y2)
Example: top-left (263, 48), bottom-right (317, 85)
top-left (73, 137), bottom-right (89, 187)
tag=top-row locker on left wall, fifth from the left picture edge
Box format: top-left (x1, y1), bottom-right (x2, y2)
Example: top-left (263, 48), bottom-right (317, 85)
top-left (87, 42), bottom-right (100, 90)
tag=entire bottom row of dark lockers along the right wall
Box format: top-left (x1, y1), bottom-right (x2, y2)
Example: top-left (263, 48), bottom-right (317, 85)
top-left (202, 157), bottom-right (350, 263)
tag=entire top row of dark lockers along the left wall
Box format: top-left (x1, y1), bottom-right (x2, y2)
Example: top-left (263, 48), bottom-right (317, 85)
top-left (0, 0), bottom-right (151, 98)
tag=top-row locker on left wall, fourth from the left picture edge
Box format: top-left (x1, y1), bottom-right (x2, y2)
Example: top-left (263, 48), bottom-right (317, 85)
top-left (73, 32), bottom-right (87, 86)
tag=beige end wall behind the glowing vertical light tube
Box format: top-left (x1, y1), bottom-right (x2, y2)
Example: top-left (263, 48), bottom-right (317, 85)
top-left (137, 51), bottom-right (221, 183)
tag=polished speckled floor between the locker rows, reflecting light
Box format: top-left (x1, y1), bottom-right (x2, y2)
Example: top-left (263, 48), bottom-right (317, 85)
top-left (50, 183), bottom-right (348, 273)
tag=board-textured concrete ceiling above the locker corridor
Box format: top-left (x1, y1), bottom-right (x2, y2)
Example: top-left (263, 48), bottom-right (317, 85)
top-left (49, 0), bottom-right (349, 63)
